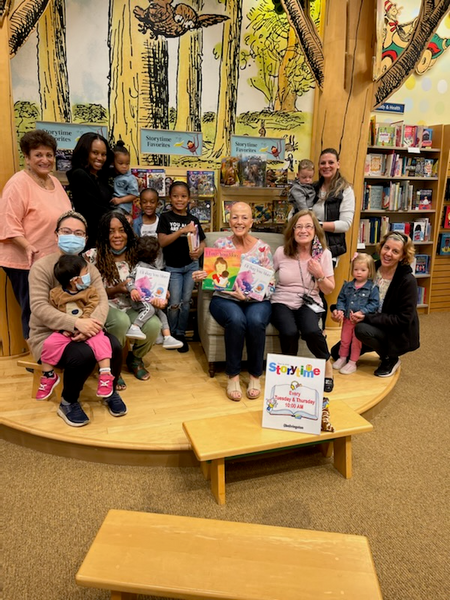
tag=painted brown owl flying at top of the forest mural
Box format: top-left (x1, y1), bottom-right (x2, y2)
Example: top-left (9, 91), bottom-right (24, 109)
top-left (133, 0), bottom-right (229, 38)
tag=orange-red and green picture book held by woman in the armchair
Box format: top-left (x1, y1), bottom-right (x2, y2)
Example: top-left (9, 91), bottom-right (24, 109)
top-left (202, 248), bottom-right (241, 292)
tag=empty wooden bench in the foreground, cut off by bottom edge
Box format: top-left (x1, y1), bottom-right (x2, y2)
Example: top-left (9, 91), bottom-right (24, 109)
top-left (75, 510), bottom-right (382, 600)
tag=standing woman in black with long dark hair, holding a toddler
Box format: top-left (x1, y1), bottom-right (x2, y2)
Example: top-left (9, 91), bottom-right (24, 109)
top-left (67, 132), bottom-right (114, 248)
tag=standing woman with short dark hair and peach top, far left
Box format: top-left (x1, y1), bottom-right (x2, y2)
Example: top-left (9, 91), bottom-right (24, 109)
top-left (0, 129), bottom-right (70, 339)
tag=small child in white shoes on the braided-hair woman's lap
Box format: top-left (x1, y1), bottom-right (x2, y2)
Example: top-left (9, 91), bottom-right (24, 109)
top-left (126, 236), bottom-right (183, 350)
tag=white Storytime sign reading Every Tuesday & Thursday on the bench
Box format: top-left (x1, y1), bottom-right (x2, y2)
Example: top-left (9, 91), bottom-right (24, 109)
top-left (262, 354), bottom-right (325, 435)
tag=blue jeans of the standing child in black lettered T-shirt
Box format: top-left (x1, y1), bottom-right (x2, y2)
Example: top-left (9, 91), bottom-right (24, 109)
top-left (166, 260), bottom-right (199, 335)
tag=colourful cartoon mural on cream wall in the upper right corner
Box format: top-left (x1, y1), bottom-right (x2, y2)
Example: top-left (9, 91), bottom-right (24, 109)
top-left (377, 0), bottom-right (450, 125)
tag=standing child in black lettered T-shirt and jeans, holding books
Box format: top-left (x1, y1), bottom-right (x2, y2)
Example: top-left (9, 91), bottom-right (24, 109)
top-left (157, 181), bottom-right (205, 352)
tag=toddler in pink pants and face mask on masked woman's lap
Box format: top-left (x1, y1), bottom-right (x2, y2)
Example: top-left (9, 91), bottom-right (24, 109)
top-left (36, 254), bottom-right (114, 400)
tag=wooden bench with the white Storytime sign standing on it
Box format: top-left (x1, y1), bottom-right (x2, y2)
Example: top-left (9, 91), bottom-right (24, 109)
top-left (183, 400), bottom-right (373, 504)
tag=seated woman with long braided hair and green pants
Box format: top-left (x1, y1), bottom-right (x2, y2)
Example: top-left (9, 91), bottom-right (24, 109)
top-left (85, 210), bottom-right (163, 389)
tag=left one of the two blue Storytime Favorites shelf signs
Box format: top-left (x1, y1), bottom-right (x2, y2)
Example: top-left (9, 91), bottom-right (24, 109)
top-left (141, 129), bottom-right (203, 156)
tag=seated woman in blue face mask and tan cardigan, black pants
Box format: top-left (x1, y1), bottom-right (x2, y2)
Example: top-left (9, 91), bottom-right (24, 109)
top-left (29, 211), bottom-right (127, 427)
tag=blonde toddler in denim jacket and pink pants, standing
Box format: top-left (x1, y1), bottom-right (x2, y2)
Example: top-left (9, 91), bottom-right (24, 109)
top-left (333, 253), bottom-right (380, 375)
